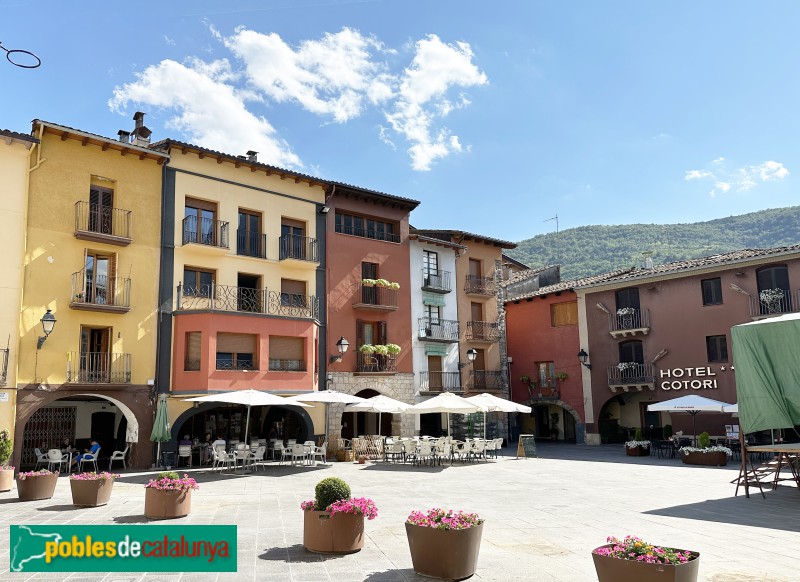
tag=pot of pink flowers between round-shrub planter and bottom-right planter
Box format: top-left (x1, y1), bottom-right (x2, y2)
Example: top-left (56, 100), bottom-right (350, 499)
top-left (406, 507), bottom-right (484, 580)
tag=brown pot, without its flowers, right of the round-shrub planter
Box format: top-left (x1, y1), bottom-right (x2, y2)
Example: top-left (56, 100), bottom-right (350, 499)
top-left (406, 523), bottom-right (483, 580)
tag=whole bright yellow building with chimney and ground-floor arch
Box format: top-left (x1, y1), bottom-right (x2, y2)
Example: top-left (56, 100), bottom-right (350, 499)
top-left (14, 113), bottom-right (167, 466)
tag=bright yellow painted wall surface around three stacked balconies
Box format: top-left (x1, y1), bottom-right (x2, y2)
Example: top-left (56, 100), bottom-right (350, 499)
top-left (19, 133), bottom-right (162, 386)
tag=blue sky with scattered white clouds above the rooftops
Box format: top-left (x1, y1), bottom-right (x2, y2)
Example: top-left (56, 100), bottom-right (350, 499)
top-left (0, 0), bottom-right (800, 241)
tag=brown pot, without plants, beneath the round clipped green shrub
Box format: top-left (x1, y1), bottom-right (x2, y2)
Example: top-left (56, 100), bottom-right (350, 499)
top-left (303, 511), bottom-right (364, 554)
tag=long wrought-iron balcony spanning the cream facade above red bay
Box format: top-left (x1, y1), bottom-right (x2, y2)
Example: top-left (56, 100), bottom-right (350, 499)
top-left (176, 283), bottom-right (319, 320)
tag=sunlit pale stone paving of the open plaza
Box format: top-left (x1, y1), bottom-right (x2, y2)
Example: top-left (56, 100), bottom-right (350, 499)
top-left (0, 444), bottom-right (800, 582)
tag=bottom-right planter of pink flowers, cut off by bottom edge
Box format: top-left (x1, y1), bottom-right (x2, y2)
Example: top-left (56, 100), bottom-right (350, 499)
top-left (592, 536), bottom-right (700, 582)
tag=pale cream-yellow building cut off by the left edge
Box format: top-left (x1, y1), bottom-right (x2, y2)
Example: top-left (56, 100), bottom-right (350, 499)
top-left (0, 130), bottom-right (38, 442)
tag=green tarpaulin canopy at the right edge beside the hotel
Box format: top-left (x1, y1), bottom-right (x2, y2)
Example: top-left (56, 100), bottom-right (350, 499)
top-left (731, 313), bottom-right (800, 433)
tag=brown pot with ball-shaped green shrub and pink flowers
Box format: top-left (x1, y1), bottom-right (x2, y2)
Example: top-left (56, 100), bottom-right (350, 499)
top-left (300, 477), bottom-right (378, 554)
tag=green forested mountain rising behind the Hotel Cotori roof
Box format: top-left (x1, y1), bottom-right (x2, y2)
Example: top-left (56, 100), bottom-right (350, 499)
top-left (507, 206), bottom-right (800, 280)
